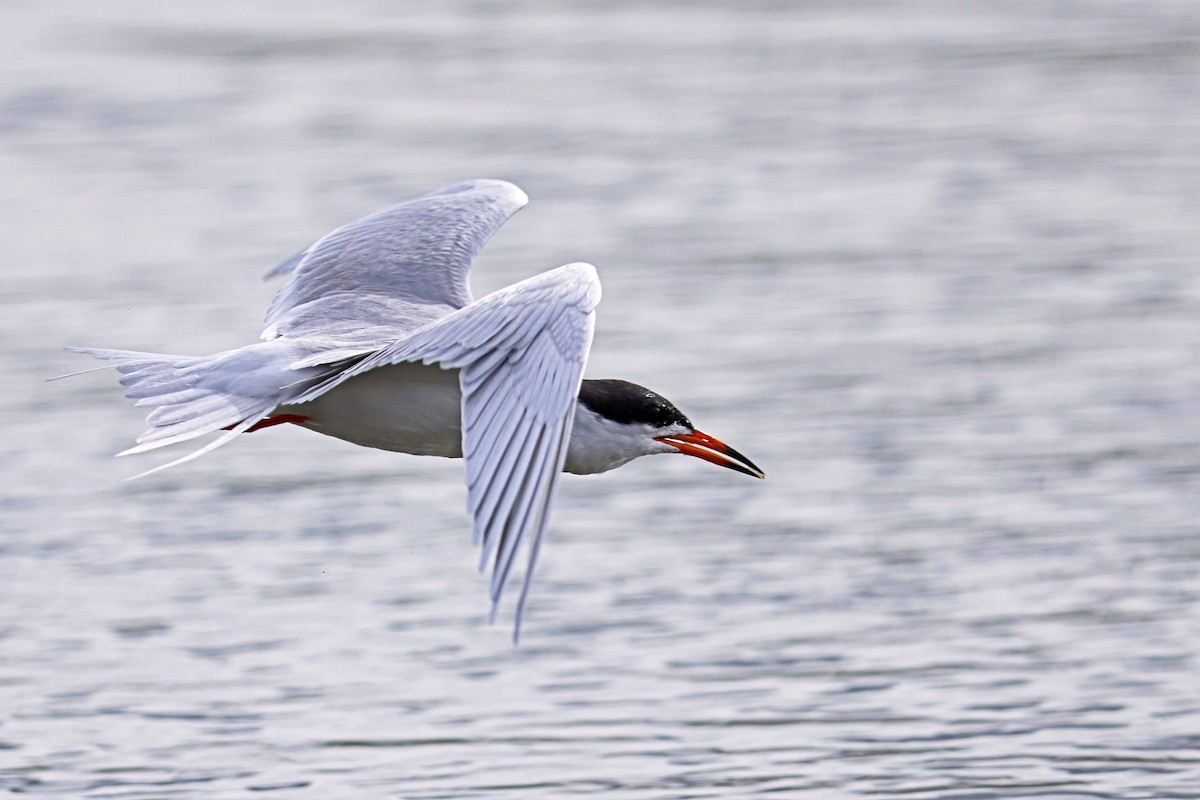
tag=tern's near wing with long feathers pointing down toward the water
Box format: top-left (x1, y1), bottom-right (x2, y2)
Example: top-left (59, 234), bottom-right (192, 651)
top-left (292, 264), bottom-right (600, 638)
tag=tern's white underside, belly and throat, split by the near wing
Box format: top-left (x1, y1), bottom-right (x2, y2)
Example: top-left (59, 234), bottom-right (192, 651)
top-left (285, 363), bottom-right (676, 475)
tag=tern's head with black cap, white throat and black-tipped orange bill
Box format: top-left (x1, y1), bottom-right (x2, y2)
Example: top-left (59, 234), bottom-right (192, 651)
top-left (565, 379), bottom-right (766, 477)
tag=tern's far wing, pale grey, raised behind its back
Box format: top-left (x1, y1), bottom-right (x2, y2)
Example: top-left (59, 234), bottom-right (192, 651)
top-left (263, 180), bottom-right (529, 342)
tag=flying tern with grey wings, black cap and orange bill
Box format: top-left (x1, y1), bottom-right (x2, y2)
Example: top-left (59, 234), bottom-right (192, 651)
top-left (61, 179), bottom-right (764, 642)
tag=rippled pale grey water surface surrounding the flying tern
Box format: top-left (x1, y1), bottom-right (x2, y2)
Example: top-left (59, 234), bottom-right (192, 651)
top-left (0, 0), bottom-right (1200, 800)
